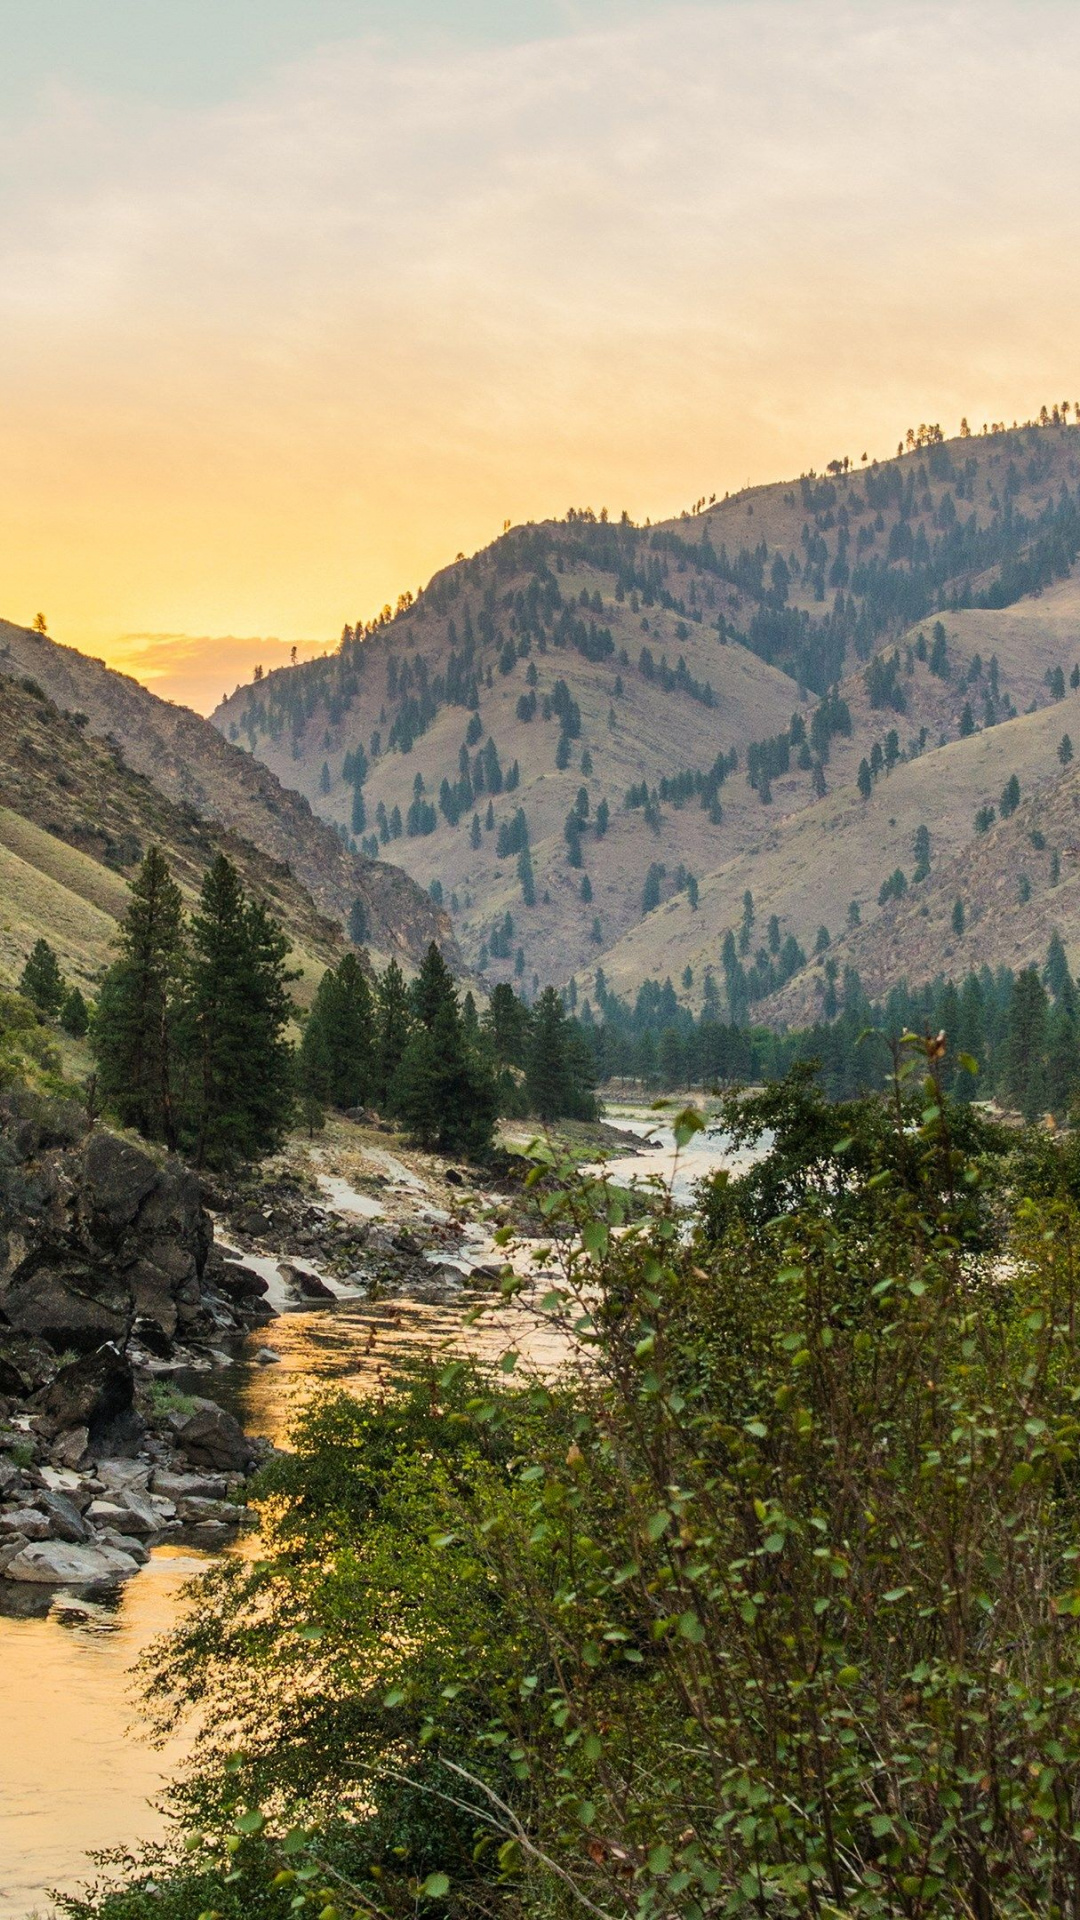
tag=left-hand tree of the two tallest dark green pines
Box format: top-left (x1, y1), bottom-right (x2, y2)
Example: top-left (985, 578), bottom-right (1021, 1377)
top-left (92, 847), bottom-right (184, 1148)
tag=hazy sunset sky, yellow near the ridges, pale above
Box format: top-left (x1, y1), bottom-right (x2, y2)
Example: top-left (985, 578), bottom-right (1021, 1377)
top-left (0, 0), bottom-right (1080, 710)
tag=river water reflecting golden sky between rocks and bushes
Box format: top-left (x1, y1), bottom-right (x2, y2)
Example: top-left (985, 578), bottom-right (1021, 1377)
top-left (0, 1108), bottom-right (749, 1920)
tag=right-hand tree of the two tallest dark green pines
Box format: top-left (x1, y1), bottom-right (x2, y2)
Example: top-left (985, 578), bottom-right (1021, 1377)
top-left (183, 854), bottom-right (296, 1165)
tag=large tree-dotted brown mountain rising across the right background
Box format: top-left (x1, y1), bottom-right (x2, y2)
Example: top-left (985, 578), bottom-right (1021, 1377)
top-left (211, 422), bottom-right (1080, 1020)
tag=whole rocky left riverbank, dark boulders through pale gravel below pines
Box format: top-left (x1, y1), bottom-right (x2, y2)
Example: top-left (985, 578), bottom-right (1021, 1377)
top-left (0, 1096), bottom-right (645, 1586)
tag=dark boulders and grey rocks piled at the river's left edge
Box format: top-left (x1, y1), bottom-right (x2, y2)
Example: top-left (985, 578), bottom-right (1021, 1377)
top-left (0, 1100), bottom-right (273, 1584)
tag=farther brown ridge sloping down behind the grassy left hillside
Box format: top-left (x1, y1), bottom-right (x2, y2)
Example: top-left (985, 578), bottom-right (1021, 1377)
top-left (0, 622), bottom-right (461, 968)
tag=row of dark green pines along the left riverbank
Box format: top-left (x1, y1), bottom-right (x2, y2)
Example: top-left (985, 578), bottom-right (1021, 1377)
top-left (39, 847), bottom-right (596, 1167)
